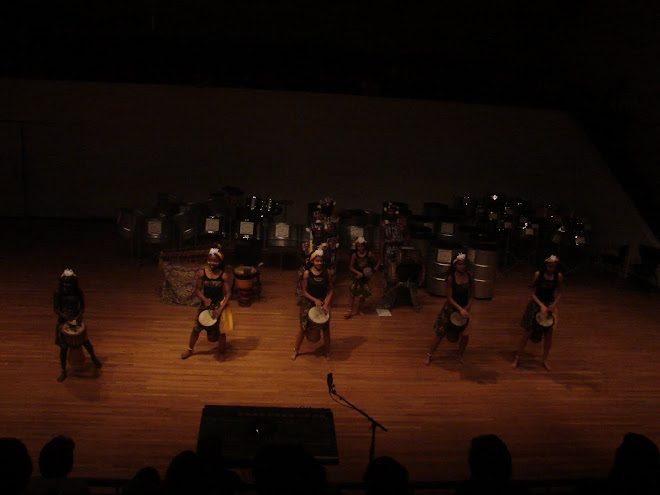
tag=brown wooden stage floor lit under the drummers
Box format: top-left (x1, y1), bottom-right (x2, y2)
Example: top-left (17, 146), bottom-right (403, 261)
top-left (0, 221), bottom-right (660, 481)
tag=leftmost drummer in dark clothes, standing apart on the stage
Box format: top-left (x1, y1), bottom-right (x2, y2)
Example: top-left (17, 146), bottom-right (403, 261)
top-left (53, 268), bottom-right (101, 382)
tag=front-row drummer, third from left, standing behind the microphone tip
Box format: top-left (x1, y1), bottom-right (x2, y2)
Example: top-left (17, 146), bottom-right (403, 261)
top-left (291, 249), bottom-right (333, 361)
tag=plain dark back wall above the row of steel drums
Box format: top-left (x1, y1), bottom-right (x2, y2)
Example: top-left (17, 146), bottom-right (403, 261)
top-left (0, 79), bottom-right (653, 252)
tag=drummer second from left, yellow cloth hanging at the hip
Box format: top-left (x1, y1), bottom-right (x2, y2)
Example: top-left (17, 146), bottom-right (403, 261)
top-left (181, 248), bottom-right (231, 359)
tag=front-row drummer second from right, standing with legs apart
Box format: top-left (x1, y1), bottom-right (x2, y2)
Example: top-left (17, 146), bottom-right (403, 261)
top-left (426, 253), bottom-right (474, 366)
